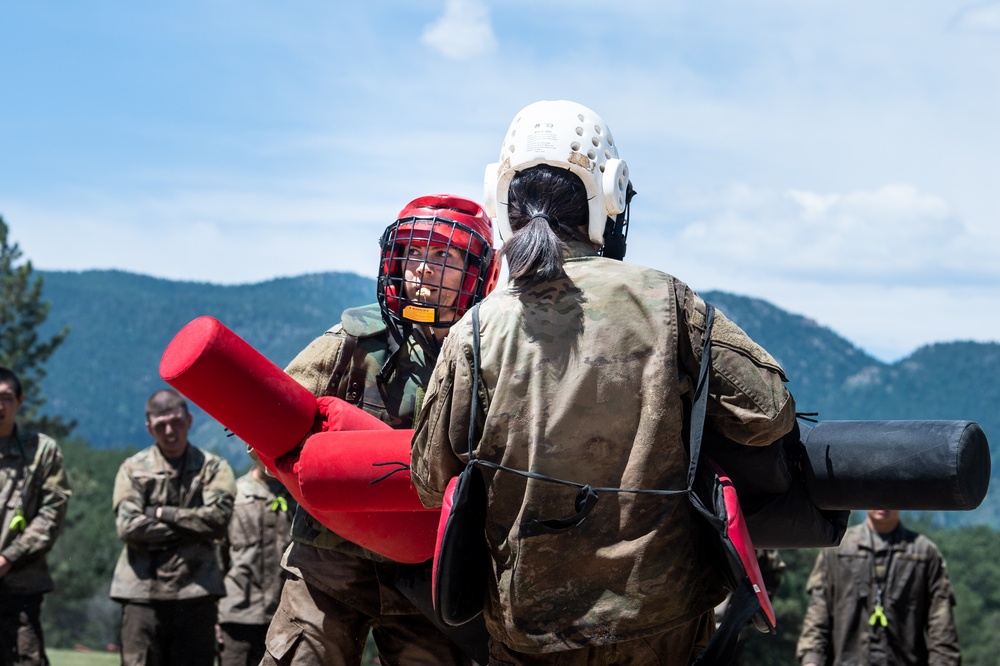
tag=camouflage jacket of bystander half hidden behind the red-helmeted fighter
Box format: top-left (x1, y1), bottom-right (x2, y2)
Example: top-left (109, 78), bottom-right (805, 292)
top-left (219, 472), bottom-right (296, 624)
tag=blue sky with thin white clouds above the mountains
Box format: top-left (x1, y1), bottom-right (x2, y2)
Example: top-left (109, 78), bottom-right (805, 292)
top-left (0, 0), bottom-right (1000, 361)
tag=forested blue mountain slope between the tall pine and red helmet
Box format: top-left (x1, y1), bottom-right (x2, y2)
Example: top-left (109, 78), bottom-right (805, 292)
top-left (41, 271), bottom-right (375, 456)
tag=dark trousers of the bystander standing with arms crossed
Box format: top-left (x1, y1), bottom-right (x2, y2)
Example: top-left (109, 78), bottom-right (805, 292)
top-left (121, 597), bottom-right (218, 666)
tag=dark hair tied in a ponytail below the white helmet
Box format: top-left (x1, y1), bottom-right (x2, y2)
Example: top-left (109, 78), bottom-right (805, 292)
top-left (502, 165), bottom-right (589, 287)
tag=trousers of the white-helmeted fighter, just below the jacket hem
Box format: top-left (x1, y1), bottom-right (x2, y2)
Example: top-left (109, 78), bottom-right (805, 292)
top-left (489, 611), bottom-right (715, 666)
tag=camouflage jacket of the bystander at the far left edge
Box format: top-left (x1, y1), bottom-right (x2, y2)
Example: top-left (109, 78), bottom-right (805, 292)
top-left (0, 427), bottom-right (71, 595)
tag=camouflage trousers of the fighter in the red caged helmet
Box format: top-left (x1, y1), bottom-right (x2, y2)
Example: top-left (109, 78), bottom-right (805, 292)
top-left (261, 560), bottom-right (470, 666)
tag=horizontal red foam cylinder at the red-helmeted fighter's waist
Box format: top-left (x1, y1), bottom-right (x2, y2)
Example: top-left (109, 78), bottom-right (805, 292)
top-left (296, 429), bottom-right (438, 512)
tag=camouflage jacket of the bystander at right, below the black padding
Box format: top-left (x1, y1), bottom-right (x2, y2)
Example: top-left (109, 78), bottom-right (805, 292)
top-left (796, 522), bottom-right (961, 666)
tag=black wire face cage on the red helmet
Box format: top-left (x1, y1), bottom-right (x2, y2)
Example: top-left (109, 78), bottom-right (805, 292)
top-left (378, 217), bottom-right (492, 328)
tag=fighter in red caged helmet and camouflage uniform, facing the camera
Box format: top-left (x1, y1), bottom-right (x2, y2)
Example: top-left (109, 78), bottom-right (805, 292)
top-left (261, 195), bottom-right (500, 666)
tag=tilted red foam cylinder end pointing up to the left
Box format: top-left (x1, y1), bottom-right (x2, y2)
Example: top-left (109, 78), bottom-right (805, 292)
top-left (160, 317), bottom-right (317, 458)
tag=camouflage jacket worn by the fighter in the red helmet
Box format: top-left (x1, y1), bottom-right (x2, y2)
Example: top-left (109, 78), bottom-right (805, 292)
top-left (283, 305), bottom-right (433, 613)
